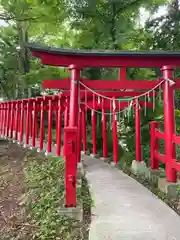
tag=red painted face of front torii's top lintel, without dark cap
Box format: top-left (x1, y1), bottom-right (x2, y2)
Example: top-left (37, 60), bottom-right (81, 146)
top-left (32, 50), bottom-right (180, 68)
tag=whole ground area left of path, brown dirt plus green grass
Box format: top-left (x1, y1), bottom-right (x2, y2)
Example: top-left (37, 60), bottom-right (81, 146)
top-left (0, 142), bottom-right (91, 240)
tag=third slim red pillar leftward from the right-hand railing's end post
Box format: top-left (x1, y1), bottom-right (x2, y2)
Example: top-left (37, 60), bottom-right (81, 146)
top-left (102, 99), bottom-right (108, 159)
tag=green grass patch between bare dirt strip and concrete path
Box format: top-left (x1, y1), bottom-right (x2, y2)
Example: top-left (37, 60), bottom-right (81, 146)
top-left (25, 156), bottom-right (91, 240)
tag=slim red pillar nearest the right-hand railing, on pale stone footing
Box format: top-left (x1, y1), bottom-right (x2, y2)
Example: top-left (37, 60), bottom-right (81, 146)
top-left (135, 99), bottom-right (142, 162)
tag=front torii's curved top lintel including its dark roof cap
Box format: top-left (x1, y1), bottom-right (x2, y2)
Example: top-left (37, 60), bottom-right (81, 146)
top-left (26, 44), bottom-right (180, 68)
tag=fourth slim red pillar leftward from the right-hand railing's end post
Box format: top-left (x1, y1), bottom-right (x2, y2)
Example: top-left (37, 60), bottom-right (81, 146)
top-left (91, 94), bottom-right (97, 157)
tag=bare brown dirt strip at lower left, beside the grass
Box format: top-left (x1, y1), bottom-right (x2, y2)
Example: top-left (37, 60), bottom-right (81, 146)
top-left (0, 140), bottom-right (33, 240)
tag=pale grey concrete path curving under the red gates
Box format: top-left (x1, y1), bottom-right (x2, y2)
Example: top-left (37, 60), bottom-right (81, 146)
top-left (82, 155), bottom-right (180, 240)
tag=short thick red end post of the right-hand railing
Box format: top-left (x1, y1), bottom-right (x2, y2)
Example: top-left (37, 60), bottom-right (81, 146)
top-left (150, 121), bottom-right (159, 169)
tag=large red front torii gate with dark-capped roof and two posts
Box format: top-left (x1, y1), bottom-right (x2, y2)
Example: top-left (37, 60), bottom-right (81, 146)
top-left (28, 45), bottom-right (180, 207)
